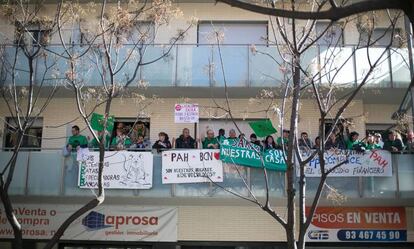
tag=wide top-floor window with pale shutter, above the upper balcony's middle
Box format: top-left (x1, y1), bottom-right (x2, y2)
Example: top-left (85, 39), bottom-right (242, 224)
top-left (197, 21), bottom-right (268, 45)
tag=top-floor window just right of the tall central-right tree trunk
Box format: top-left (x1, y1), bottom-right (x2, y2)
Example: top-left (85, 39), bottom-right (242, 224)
top-left (315, 22), bottom-right (344, 47)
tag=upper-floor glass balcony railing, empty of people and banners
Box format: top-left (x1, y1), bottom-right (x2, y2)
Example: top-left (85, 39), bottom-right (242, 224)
top-left (1, 45), bottom-right (410, 88)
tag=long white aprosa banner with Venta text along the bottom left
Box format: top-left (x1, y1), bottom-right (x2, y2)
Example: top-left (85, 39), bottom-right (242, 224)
top-left (0, 204), bottom-right (177, 242)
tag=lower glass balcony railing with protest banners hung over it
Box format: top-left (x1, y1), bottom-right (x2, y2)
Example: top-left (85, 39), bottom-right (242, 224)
top-left (0, 150), bottom-right (414, 199)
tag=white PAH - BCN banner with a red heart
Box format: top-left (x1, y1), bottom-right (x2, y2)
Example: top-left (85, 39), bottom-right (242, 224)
top-left (162, 150), bottom-right (223, 184)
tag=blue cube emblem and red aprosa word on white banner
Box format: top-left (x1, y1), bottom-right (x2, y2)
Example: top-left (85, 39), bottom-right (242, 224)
top-left (82, 211), bottom-right (158, 230)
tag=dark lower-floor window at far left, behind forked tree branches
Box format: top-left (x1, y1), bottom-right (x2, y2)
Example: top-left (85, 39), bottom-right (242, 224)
top-left (3, 117), bottom-right (43, 150)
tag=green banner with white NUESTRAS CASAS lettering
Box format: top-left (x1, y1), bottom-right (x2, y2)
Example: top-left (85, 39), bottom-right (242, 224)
top-left (220, 139), bottom-right (286, 171)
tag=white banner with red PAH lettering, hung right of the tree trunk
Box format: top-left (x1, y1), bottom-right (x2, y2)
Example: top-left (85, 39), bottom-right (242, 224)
top-left (296, 150), bottom-right (392, 177)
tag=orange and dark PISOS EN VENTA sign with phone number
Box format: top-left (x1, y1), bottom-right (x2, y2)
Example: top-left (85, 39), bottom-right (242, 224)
top-left (307, 207), bottom-right (407, 242)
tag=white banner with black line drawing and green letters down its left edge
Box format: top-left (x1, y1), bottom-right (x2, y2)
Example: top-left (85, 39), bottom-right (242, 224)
top-left (78, 151), bottom-right (153, 189)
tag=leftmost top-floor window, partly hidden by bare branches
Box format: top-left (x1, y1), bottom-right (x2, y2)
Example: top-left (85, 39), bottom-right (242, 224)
top-left (15, 23), bottom-right (50, 46)
